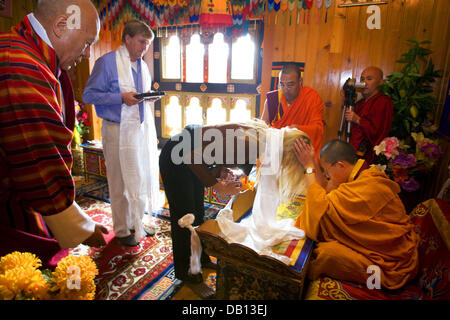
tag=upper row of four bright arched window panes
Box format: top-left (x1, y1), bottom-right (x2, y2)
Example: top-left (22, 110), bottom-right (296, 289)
top-left (161, 28), bottom-right (257, 84)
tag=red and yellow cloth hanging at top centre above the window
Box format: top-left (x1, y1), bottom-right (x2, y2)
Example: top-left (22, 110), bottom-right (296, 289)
top-left (199, 0), bottom-right (233, 28)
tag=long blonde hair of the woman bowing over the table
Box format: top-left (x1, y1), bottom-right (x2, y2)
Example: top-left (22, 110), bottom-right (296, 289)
top-left (277, 128), bottom-right (310, 203)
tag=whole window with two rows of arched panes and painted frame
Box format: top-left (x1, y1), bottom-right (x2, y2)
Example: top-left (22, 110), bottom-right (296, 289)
top-left (153, 22), bottom-right (263, 142)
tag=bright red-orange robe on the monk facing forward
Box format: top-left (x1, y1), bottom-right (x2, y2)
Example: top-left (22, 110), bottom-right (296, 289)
top-left (271, 87), bottom-right (324, 157)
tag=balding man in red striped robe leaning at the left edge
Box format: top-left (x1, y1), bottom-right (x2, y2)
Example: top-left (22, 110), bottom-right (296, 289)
top-left (0, 0), bottom-right (107, 267)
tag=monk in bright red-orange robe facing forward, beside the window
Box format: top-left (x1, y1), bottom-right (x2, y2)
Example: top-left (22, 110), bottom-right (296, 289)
top-left (261, 64), bottom-right (323, 157)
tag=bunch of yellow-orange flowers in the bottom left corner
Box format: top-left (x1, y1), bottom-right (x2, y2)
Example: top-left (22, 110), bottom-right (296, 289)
top-left (0, 252), bottom-right (98, 300)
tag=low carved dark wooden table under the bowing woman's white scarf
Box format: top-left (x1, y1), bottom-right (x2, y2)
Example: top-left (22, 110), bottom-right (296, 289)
top-left (197, 191), bottom-right (313, 300)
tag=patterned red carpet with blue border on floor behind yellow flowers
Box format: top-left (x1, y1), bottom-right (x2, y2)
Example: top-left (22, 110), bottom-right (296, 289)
top-left (71, 197), bottom-right (180, 300)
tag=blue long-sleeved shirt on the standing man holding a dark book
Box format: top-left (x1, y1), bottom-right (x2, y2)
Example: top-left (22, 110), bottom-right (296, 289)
top-left (83, 51), bottom-right (144, 123)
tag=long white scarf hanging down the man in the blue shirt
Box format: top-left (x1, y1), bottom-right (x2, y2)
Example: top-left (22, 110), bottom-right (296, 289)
top-left (116, 45), bottom-right (161, 241)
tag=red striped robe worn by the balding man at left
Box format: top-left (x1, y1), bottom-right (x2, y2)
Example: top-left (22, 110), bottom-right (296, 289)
top-left (0, 17), bottom-right (75, 238)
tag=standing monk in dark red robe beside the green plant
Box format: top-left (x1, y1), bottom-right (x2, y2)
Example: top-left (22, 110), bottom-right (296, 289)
top-left (345, 67), bottom-right (394, 163)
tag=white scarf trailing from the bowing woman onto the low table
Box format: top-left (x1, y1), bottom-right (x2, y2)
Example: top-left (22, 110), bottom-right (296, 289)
top-left (216, 128), bottom-right (305, 264)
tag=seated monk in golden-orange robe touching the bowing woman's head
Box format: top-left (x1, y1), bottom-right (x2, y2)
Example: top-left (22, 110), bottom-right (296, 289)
top-left (295, 140), bottom-right (419, 289)
